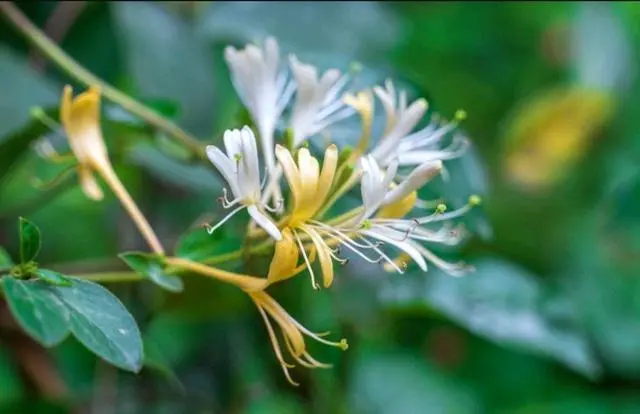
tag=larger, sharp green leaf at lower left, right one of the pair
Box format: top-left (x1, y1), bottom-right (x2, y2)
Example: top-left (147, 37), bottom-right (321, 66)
top-left (52, 278), bottom-right (143, 372)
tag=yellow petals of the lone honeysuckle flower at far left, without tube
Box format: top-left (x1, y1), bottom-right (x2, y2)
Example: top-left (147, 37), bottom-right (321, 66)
top-left (60, 85), bottom-right (110, 200)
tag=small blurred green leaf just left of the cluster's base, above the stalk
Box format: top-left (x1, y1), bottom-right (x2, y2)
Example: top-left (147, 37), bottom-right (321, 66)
top-left (176, 228), bottom-right (241, 261)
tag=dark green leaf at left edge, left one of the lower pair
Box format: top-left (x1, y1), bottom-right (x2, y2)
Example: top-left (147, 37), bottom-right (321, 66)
top-left (2, 277), bottom-right (69, 347)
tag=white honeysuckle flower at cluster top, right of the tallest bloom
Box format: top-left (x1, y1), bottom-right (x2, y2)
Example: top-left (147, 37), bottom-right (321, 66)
top-left (289, 55), bottom-right (355, 147)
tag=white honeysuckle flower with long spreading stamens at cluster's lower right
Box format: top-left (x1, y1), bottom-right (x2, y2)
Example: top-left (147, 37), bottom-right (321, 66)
top-left (307, 155), bottom-right (478, 276)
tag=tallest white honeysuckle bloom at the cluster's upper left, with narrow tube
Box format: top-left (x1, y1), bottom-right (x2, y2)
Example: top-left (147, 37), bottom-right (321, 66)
top-left (224, 37), bottom-right (295, 172)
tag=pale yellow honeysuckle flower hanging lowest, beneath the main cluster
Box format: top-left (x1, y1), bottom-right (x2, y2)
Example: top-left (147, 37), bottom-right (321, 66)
top-left (247, 291), bottom-right (349, 385)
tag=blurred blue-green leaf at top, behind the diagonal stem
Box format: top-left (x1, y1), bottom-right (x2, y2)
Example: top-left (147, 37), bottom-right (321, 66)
top-left (110, 2), bottom-right (215, 135)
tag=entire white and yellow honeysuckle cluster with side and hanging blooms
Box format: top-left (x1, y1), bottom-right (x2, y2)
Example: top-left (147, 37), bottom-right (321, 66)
top-left (40, 38), bottom-right (480, 384)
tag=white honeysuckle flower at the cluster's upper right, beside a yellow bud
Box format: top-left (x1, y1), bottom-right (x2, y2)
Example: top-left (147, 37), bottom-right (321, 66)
top-left (371, 80), bottom-right (468, 171)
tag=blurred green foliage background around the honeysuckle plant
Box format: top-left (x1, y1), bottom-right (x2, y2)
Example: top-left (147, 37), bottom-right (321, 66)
top-left (0, 1), bottom-right (640, 414)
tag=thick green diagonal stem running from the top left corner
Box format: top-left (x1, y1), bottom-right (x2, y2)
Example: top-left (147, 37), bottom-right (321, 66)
top-left (0, 1), bottom-right (205, 159)
